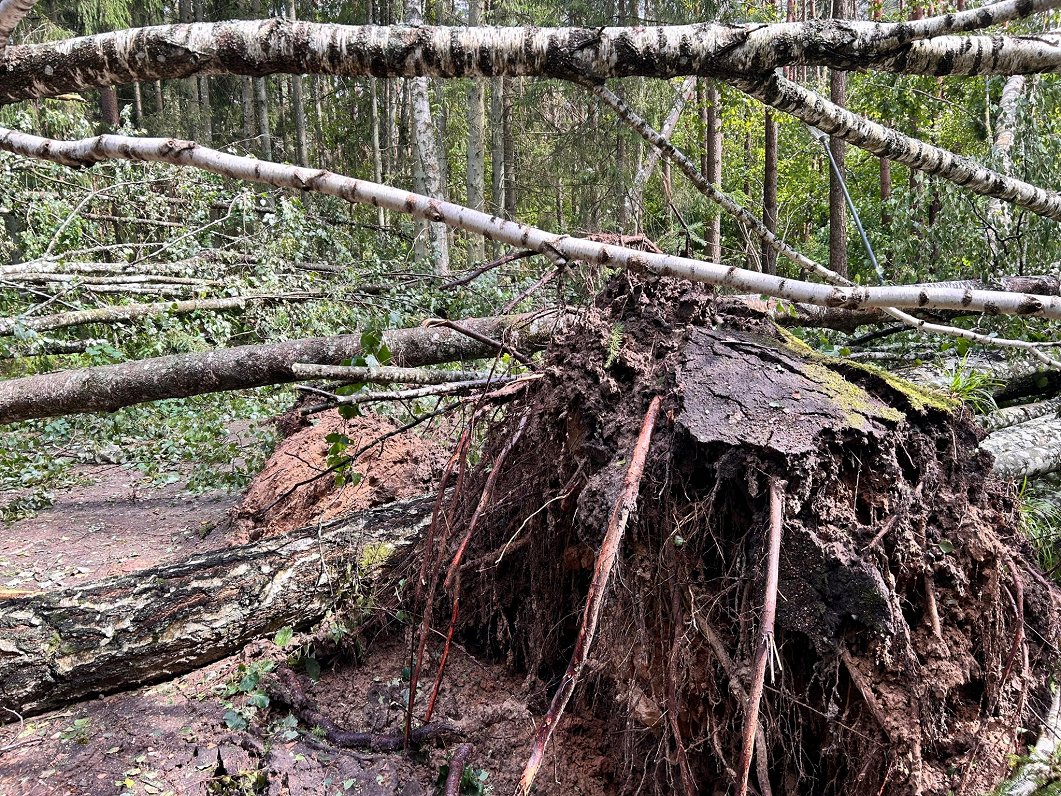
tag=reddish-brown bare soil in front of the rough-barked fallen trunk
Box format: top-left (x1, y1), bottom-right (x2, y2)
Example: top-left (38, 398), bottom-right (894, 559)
top-left (0, 641), bottom-right (611, 796)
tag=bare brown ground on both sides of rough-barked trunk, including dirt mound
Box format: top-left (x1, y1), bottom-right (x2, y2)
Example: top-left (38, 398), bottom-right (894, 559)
top-left (0, 415), bottom-right (611, 796)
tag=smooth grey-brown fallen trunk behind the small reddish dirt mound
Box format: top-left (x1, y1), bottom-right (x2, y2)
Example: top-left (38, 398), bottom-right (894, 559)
top-left (0, 315), bottom-right (556, 423)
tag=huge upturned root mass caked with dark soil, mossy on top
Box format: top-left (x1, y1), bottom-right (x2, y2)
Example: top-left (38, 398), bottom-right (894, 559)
top-left (403, 276), bottom-right (1059, 794)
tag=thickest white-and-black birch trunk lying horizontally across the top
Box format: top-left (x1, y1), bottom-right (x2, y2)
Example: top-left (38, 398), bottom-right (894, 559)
top-left (8, 0), bottom-right (1061, 102)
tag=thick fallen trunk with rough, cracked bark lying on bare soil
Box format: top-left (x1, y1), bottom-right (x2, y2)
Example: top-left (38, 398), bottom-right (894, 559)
top-left (0, 498), bottom-right (434, 723)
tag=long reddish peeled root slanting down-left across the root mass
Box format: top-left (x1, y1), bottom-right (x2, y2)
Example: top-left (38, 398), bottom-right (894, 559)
top-left (520, 396), bottom-right (662, 796)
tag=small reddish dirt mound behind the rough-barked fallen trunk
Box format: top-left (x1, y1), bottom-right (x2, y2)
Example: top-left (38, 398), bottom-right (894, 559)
top-left (236, 410), bottom-right (446, 538)
